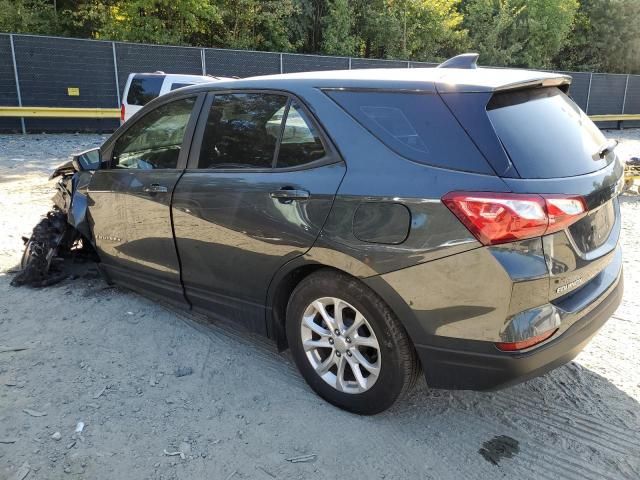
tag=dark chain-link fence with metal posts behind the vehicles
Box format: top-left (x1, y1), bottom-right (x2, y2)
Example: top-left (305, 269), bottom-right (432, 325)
top-left (0, 34), bottom-right (640, 132)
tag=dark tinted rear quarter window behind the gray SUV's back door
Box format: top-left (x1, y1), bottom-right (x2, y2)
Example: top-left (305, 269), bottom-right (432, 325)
top-left (326, 90), bottom-right (494, 174)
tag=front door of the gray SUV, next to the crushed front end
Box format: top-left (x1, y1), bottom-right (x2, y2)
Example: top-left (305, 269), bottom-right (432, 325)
top-left (89, 96), bottom-right (204, 301)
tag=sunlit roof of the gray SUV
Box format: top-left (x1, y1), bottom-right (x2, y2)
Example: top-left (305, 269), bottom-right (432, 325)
top-left (182, 68), bottom-right (571, 93)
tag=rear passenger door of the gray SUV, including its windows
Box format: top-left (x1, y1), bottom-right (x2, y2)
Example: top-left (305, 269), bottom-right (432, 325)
top-left (173, 91), bottom-right (345, 332)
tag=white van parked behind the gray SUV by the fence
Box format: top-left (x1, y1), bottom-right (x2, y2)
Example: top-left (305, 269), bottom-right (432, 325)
top-left (120, 72), bottom-right (232, 123)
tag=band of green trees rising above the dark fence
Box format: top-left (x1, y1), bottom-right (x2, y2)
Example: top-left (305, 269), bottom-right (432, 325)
top-left (0, 0), bottom-right (640, 73)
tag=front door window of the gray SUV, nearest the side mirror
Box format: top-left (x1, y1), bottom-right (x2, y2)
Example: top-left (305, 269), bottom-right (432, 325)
top-left (112, 97), bottom-right (196, 169)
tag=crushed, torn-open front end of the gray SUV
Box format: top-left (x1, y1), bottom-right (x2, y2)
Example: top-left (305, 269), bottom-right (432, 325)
top-left (11, 152), bottom-right (97, 287)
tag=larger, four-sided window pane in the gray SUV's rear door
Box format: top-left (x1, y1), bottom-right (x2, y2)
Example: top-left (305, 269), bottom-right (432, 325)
top-left (198, 93), bottom-right (287, 168)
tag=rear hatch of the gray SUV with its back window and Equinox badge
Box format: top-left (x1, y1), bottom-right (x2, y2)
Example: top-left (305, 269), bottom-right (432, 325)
top-left (442, 85), bottom-right (623, 304)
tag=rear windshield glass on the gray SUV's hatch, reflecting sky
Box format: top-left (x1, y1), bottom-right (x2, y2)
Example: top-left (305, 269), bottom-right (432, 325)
top-left (487, 87), bottom-right (608, 178)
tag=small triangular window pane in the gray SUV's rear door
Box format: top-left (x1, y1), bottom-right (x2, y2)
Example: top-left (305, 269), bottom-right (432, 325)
top-left (276, 100), bottom-right (325, 168)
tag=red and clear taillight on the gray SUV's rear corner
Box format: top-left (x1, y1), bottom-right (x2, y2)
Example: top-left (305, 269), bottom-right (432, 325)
top-left (442, 192), bottom-right (586, 245)
